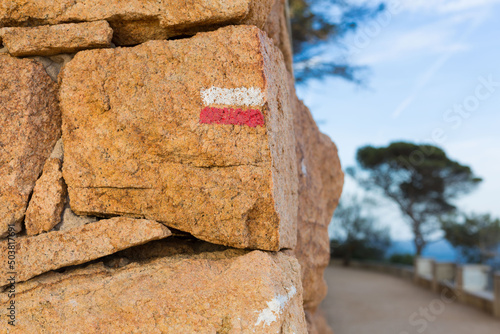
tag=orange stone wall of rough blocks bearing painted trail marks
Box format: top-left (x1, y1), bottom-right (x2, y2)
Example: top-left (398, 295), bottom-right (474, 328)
top-left (0, 0), bottom-right (343, 334)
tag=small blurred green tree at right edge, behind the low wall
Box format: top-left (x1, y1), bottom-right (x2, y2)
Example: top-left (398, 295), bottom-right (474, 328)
top-left (441, 213), bottom-right (500, 263)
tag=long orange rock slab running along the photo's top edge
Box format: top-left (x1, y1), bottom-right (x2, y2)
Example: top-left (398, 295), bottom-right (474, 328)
top-left (0, 0), bottom-right (273, 45)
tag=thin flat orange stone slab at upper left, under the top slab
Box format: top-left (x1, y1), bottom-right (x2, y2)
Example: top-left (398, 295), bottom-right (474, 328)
top-left (2, 21), bottom-right (113, 57)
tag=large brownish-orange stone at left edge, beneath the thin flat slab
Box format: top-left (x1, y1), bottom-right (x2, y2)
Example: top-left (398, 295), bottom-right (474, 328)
top-left (0, 55), bottom-right (61, 237)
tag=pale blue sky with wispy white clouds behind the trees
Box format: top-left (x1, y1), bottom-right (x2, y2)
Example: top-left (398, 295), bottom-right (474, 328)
top-left (298, 0), bottom-right (500, 240)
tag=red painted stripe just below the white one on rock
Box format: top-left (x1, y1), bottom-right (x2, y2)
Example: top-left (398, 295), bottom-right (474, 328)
top-left (200, 107), bottom-right (264, 128)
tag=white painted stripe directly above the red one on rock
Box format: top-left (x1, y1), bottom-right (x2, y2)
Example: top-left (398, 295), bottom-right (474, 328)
top-left (201, 87), bottom-right (264, 106)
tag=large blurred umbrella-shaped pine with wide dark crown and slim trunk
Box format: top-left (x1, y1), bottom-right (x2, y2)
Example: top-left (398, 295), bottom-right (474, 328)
top-left (347, 142), bottom-right (481, 255)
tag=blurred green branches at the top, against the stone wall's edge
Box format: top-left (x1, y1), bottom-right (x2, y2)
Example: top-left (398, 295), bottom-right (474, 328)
top-left (289, 0), bottom-right (385, 83)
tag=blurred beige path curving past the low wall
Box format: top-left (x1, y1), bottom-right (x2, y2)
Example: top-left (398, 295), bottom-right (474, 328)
top-left (323, 267), bottom-right (500, 334)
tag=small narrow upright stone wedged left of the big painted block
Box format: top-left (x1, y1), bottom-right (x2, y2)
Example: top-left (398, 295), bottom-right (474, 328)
top-left (24, 158), bottom-right (66, 235)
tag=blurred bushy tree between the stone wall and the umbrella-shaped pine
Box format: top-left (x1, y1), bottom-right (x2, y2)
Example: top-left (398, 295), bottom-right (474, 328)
top-left (330, 196), bottom-right (390, 266)
